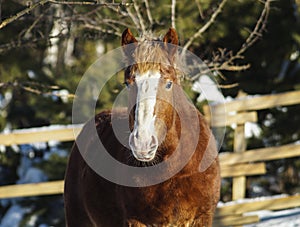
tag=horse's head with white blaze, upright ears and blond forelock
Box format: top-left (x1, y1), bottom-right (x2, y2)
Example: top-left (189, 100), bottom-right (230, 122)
top-left (122, 28), bottom-right (179, 162)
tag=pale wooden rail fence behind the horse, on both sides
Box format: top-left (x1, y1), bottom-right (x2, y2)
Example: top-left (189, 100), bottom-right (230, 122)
top-left (0, 91), bottom-right (300, 227)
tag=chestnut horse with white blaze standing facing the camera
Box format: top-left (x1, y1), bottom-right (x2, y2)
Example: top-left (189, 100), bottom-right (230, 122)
top-left (64, 28), bottom-right (220, 227)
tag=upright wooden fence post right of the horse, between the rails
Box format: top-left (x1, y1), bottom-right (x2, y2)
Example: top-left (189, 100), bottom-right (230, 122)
top-left (232, 124), bottom-right (246, 200)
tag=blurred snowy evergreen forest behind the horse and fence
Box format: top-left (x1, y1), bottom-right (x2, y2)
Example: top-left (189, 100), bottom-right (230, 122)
top-left (0, 0), bottom-right (300, 227)
